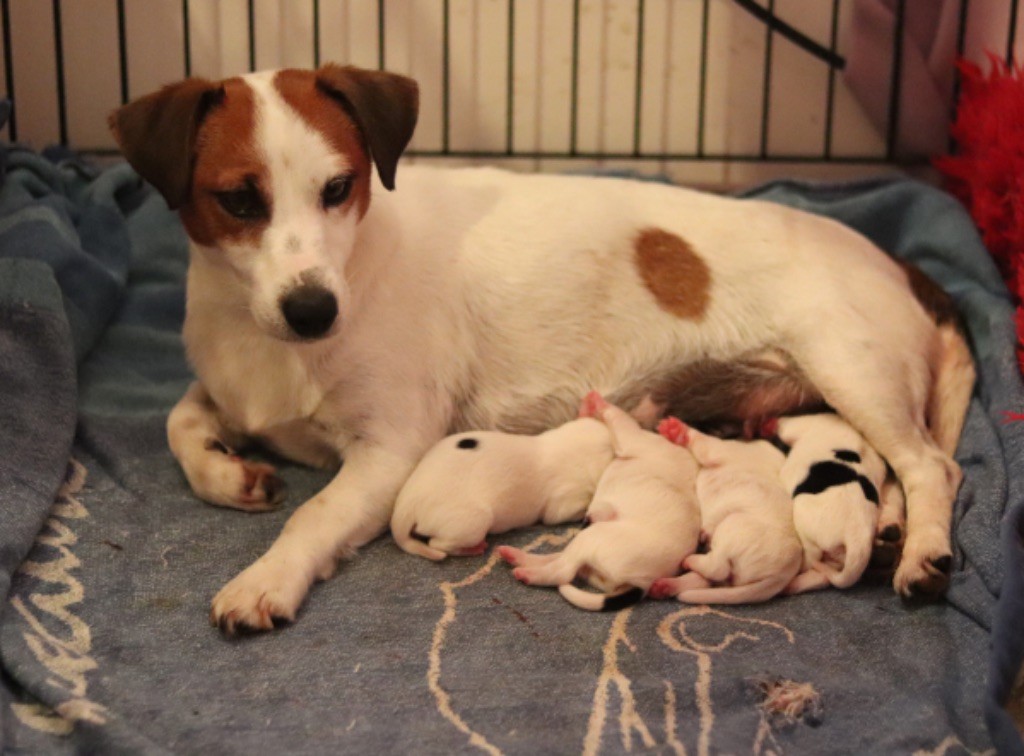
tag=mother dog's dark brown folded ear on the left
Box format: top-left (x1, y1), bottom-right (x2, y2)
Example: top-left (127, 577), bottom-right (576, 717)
top-left (108, 79), bottom-right (224, 210)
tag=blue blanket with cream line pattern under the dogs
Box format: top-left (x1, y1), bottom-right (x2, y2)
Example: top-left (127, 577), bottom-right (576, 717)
top-left (0, 149), bottom-right (1024, 754)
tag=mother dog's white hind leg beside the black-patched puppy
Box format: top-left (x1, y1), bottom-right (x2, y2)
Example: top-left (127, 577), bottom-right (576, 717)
top-left (798, 324), bottom-right (962, 596)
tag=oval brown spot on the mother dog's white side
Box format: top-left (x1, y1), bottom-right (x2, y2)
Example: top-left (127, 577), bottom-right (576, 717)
top-left (633, 223), bottom-right (711, 321)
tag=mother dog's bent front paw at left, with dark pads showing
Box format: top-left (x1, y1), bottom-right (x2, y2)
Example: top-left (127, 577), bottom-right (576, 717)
top-left (189, 449), bottom-right (285, 512)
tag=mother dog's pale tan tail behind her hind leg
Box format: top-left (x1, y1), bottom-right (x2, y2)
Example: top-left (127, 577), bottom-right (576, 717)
top-left (928, 322), bottom-right (977, 457)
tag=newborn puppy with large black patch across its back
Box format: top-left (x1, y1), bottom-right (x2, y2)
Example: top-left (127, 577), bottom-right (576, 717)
top-left (766, 414), bottom-right (886, 593)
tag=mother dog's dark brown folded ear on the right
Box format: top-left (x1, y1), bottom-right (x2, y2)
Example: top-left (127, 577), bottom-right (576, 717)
top-left (316, 64), bottom-right (420, 190)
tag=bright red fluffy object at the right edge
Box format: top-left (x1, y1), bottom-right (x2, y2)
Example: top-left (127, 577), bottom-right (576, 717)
top-left (935, 54), bottom-right (1024, 371)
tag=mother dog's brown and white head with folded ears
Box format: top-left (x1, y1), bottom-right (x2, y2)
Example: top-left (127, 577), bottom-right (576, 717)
top-left (110, 65), bottom-right (418, 340)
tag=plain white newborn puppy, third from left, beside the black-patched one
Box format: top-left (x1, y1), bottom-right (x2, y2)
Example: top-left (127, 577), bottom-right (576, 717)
top-left (650, 418), bottom-right (802, 603)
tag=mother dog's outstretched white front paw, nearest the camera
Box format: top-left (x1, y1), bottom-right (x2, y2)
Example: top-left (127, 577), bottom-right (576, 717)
top-left (210, 561), bottom-right (309, 635)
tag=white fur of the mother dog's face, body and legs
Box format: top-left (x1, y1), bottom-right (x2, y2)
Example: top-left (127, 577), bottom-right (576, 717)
top-left (108, 66), bottom-right (967, 632)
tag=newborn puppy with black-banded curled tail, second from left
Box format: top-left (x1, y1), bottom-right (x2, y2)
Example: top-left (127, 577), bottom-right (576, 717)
top-left (498, 392), bottom-right (700, 611)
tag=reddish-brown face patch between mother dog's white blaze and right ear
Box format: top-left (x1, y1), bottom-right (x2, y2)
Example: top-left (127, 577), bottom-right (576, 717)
top-left (273, 70), bottom-right (372, 218)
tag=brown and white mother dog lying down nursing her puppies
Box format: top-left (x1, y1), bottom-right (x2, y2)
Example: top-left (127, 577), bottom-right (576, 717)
top-left (111, 65), bottom-right (973, 633)
